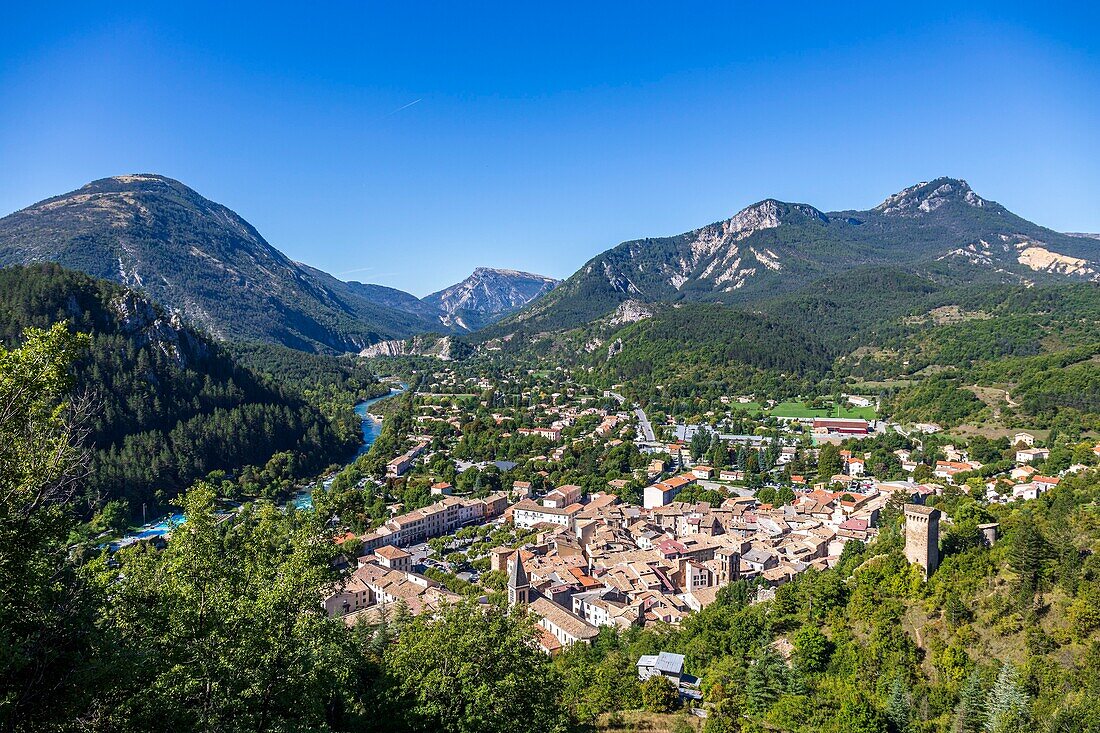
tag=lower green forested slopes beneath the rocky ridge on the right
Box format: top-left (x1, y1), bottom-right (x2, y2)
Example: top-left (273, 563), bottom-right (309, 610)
top-left (479, 260), bottom-right (1100, 431)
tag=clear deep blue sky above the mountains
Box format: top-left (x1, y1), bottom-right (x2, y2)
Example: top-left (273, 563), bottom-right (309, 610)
top-left (0, 1), bottom-right (1100, 295)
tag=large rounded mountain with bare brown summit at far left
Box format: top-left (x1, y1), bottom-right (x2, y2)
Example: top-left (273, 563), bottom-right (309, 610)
top-left (0, 174), bottom-right (440, 352)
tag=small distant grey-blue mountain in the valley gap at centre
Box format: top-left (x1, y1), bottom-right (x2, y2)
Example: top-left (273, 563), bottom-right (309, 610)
top-left (424, 267), bottom-right (558, 331)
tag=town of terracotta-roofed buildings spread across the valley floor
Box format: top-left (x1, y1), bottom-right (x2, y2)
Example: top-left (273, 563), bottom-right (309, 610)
top-left (325, 358), bottom-right (1100, 654)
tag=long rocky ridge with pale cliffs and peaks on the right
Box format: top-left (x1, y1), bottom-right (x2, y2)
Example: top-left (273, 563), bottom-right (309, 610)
top-left (497, 178), bottom-right (1100, 337)
